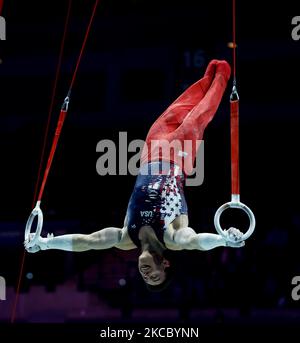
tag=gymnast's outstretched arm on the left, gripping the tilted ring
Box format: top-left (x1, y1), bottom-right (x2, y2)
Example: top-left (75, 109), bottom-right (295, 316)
top-left (24, 227), bottom-right (135, 252)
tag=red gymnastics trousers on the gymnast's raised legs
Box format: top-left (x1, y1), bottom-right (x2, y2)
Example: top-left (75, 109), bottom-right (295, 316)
top-left (141, 60), bottom-right (230, 175)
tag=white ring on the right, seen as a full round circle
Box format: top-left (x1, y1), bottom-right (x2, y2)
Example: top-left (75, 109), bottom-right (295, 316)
top-left (214, 201), bottom-right (256, 242)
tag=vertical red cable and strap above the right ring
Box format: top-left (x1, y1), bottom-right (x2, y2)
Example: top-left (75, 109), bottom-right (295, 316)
top-left (230, 0), bottom-right (240, 195)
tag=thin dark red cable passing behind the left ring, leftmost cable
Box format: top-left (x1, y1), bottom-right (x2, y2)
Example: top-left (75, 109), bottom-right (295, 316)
top-left (10, 0), bottom-right (72, 323)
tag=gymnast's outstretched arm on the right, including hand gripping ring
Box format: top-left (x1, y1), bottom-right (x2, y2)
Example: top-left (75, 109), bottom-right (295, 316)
top-left (173, 227), bottom-right (245, 250)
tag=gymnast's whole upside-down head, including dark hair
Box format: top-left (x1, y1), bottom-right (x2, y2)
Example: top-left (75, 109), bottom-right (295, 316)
top-left (138, 250), bottom-right (173, 291)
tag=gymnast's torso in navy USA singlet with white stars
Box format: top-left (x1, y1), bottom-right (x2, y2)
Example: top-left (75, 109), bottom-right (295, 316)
top-left (122, 161), bottom-right (187, 249)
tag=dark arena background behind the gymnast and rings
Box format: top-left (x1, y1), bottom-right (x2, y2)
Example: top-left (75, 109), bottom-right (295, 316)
top-left (0, 0), bottom-right (300, 338)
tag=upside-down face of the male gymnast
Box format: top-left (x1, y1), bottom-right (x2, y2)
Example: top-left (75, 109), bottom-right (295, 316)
top-left (138, 251), bottom-right (170, 286)
